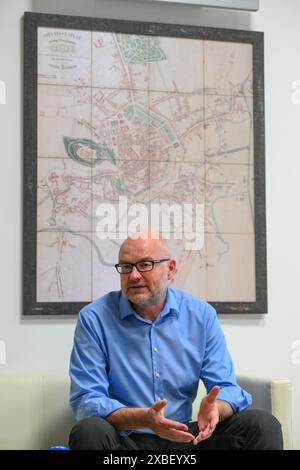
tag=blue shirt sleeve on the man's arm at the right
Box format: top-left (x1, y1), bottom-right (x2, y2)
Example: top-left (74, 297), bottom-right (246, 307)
top-left (200, 305), bottom-right (252, 412)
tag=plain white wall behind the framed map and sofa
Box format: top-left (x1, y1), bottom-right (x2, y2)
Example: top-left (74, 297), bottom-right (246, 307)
top-left (0, 0), bottom-right (300, 449)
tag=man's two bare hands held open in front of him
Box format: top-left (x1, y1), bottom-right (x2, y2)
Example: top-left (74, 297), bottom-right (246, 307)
top-left (148, 385), bottom-right (220, 445)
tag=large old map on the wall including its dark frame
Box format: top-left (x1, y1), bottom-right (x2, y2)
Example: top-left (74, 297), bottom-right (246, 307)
top-left (23, 13), bottom-right (267, 315)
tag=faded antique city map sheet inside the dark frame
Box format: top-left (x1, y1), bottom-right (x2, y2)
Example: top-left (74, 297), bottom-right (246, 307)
top-left (36, 27), bottom-right (255, 302)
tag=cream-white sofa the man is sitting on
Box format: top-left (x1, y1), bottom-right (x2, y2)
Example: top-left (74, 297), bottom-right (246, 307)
top-left (0, 373), bottom-right (292, 450)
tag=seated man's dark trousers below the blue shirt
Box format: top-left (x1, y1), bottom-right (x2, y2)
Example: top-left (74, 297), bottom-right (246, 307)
top-left (69, 410), bottom-right (283, 450)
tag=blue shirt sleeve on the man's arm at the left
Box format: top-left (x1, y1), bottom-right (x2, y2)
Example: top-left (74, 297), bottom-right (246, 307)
top-left (70, 310), bottom-right (125, 420)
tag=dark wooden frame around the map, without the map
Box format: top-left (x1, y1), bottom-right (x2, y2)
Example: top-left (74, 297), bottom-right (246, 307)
top-left (23, 13), bottom-right (267, 315)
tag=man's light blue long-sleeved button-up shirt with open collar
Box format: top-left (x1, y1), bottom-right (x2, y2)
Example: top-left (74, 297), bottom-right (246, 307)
top-left (70, 288), bottom-right (251, 433)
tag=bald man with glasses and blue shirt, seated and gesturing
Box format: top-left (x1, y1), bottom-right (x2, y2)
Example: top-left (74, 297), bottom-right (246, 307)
top-left (70, 234), bottom-right (282, 450)
